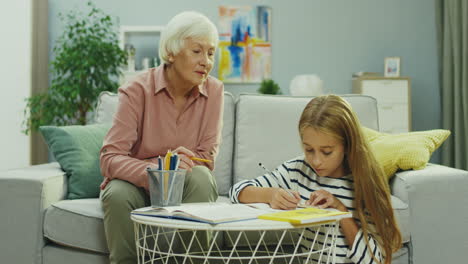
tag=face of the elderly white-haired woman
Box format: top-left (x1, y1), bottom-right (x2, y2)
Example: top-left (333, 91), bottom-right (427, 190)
top-left (172, 38), bottom-right (216, 86)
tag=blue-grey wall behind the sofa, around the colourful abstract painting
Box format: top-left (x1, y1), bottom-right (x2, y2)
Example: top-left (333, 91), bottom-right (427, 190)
top-left (49, 0), bottom-right (441, 159)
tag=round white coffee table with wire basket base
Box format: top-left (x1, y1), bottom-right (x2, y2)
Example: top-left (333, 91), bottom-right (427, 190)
top-left (131, 212), bottom-right (339, 264)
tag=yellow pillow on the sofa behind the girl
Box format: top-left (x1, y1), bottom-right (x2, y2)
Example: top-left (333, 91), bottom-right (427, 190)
top-left (363, 127), bottom-right (450, 179)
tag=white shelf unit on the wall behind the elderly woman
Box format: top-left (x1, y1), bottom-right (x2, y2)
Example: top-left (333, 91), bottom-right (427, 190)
top-left (119, 25), bottom-right (164, 84)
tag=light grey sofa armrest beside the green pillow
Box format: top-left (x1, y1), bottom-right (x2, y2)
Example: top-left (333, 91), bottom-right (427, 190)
top-left (0, 162), bottom-right (67, 264)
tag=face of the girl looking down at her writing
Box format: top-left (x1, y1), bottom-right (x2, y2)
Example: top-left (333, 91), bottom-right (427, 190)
top-left (302, 127), bottom-right (346, 178)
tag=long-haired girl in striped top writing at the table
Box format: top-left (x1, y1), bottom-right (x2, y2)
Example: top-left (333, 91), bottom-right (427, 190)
top-left (230, 95), bottom-right (401, 263)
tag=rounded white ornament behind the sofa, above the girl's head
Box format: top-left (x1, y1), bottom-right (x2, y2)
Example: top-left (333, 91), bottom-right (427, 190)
top-left (289, 74), bottom-right (323, 96)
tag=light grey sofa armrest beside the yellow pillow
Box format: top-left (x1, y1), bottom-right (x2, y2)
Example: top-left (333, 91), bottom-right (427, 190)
top-left (390, 164), bottom-right (468, 264)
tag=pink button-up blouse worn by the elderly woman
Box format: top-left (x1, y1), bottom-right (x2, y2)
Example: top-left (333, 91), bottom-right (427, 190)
top-left (100, 65), bottom-right (224, 189)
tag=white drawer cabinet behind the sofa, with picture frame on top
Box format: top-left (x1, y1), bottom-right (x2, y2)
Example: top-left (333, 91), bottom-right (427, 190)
top-left (353, 76), bottom-right (411, 134)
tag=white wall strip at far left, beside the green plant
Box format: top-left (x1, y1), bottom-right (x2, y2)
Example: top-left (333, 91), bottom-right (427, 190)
top-left (0, 0), bottom-right (34, 171)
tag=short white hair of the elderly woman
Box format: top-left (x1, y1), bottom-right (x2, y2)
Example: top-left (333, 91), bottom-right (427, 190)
top-left (159, 11), bottom-right (219, 64)
